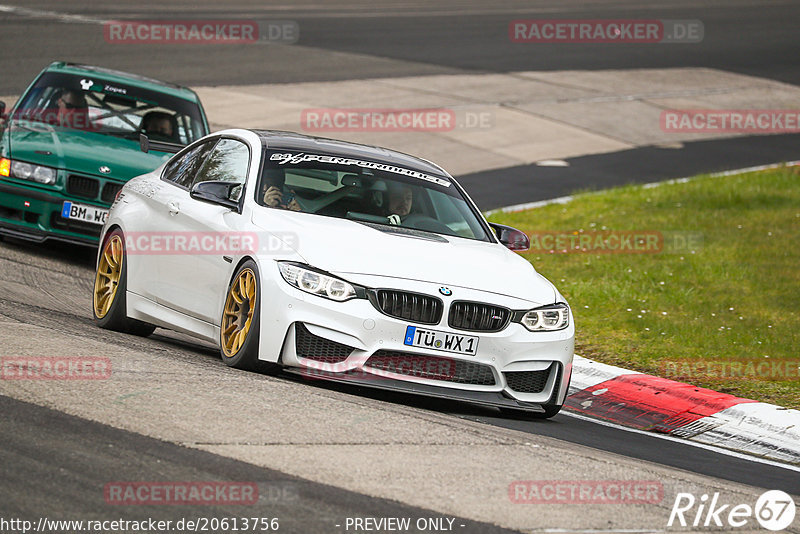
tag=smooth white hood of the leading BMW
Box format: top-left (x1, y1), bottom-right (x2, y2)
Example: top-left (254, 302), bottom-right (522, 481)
top-left (253, 212), bottom-right (556, 304)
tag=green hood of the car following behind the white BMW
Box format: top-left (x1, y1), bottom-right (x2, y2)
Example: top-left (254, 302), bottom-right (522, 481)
top-left (8, 123), bottom-right (169, 181)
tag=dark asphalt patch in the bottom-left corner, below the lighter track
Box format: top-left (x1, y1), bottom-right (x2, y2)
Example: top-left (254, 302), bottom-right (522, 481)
top-left (0, 396), bottom-right (511, 534)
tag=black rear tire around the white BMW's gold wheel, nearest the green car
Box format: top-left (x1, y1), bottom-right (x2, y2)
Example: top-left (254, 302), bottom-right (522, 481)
top-left (92, 228), bottom-right (156, 337)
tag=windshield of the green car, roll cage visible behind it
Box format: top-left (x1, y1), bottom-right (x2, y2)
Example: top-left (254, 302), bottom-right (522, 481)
top-left (12, 72), bottom-right (208, 145)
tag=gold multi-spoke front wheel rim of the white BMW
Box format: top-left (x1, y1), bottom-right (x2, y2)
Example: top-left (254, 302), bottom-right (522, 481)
top-left (221, 269), bottom-right (256, 358)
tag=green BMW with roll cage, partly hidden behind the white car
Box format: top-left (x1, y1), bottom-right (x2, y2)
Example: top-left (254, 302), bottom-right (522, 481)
top-left (0, 62), bottom-right (208, 245)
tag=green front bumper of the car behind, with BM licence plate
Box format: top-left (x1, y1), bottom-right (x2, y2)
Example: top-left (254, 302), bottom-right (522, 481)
top-left (0, 180), bottom-right (108, 246)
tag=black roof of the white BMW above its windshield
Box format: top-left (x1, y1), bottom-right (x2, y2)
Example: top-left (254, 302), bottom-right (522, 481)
top-left (250, 130), bottom-right (452, 178)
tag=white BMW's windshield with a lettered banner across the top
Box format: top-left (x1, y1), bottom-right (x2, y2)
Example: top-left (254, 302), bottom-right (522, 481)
top-left (256, 151), bottom-right (494, 240)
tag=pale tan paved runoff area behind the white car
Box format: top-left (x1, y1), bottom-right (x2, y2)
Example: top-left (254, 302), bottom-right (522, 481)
top-left (189, 68), bottom-right (800, 177)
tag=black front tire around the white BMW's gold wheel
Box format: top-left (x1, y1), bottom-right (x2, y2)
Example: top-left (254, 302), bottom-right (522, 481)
top-left (219, 260), bottom-right (281, 374)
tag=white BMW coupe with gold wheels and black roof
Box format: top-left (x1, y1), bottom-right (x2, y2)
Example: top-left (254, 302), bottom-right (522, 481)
top-left (93, 129), bottom-right (575, 418)
